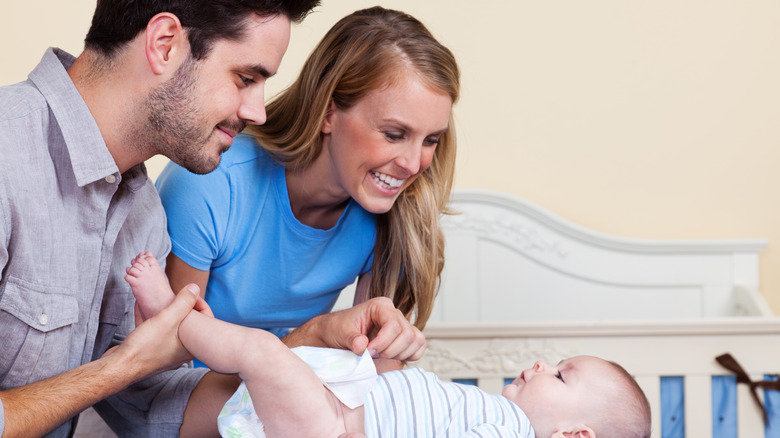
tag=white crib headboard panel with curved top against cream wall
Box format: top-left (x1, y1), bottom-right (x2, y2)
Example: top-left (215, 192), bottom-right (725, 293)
top-left (431, 186), bottom-right (771, 322)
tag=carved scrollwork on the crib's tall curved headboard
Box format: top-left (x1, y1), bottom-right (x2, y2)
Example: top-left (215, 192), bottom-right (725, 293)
top-left (442, 215), bottom-right (570, 258)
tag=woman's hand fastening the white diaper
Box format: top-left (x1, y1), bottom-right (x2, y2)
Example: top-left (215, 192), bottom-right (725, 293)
top-left (283, 297), bottom-right (427, 361)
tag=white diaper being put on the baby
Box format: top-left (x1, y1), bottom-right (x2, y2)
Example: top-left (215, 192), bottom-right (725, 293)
top-left (217, 347), bottom-right (377, 438)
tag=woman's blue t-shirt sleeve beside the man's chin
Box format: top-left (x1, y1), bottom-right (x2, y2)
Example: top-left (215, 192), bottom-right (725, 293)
top-left (156, 163), bottom-right (231, 271)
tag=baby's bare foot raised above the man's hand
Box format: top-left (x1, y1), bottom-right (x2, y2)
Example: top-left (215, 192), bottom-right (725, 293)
top-left (125, 251), bottom-right (174, 318)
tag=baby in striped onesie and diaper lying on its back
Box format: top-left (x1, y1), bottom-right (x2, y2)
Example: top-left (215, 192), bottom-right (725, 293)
top-left (125, 252), bottom-right (650, 438)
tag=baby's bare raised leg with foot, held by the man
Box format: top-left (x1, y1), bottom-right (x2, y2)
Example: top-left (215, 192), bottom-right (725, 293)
top-left (125, 253), bottom-right (345, 437)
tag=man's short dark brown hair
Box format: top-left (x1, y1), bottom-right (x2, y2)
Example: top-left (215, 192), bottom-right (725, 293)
top-left (84, 0), bottom-right (320, 59)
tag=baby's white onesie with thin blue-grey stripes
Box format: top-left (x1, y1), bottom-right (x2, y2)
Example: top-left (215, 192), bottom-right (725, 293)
top-left (365, 368), bottom-right (534, 438)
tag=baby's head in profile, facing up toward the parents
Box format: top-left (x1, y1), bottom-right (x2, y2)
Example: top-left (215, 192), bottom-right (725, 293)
top-left (502, 356), bottom-right (650, 438)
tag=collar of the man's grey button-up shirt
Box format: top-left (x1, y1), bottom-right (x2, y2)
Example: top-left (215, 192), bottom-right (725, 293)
top-left (28, 48), bottom-right (119, 187)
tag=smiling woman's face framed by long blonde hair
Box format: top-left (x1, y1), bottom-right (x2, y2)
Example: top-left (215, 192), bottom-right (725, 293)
top-left (322, 73), bottom-right (452, 214)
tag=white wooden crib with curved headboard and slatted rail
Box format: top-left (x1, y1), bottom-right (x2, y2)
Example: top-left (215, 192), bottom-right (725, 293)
top-left (416, 190), bottom-right (780, 438)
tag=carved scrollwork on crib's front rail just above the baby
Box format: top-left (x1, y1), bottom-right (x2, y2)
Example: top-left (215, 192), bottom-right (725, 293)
top-left (417, 339), bottom-right (577, 376)
